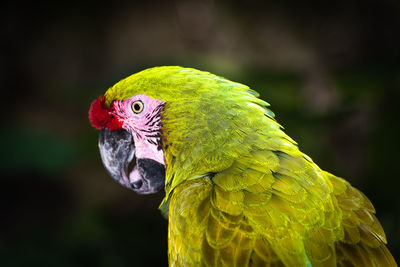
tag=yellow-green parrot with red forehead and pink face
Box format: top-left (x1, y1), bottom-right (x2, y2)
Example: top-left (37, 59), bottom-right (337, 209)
top-left (89, 66), bottom-right (397, 267)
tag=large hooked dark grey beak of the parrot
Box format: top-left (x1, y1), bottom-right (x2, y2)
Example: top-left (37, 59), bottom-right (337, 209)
top-left (99, 128), bottom-right (165, 194)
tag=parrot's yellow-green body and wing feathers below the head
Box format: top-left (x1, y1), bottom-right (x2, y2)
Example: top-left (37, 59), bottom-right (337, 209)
top-left (169, 132), bottom-right (397, 267)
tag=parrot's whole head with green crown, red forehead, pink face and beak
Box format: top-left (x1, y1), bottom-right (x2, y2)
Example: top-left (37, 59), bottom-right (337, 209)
top-left (89, 66), bottom-right (273, 198)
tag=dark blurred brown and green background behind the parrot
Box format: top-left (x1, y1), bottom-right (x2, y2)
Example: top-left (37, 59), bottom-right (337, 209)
top-left (0, 0), bottom-right (400, 267)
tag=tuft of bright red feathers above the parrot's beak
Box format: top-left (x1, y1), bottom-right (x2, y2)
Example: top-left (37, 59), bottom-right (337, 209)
top-left (89, 96), bottom-right (123, 131)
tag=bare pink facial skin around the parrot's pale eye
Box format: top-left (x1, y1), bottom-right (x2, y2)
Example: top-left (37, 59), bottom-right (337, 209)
top-left (111, 95), bottom-right (165, 186)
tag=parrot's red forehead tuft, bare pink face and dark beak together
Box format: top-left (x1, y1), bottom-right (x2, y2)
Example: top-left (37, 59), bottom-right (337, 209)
top-left (89, 95), bottom-right (165, 194)
